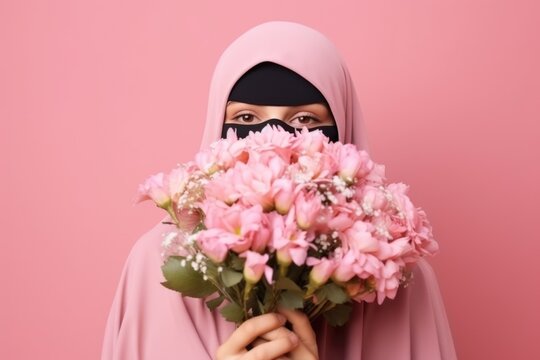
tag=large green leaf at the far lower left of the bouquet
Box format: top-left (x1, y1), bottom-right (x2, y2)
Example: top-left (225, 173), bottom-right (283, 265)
top-left (161, 256), bottom-right (217, 298)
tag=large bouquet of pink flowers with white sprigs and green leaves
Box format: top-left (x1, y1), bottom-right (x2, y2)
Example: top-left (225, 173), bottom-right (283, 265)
top-left (136, 125), bottom-right (438, 325)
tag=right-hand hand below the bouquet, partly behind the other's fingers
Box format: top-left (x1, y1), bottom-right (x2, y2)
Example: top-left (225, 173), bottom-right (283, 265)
top-left (253, 309), bottom-right (319, 360)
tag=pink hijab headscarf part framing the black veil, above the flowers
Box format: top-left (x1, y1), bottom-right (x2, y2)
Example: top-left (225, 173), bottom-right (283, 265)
top-left (201, 21), bottom-right (368, 151)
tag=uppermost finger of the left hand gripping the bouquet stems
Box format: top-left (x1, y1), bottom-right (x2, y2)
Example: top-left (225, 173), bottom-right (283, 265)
top-left (219, 313), bottom-right (287, 356)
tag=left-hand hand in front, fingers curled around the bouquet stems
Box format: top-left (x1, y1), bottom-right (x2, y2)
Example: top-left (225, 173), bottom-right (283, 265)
top-left (216, 314), bottom-right (300, 360)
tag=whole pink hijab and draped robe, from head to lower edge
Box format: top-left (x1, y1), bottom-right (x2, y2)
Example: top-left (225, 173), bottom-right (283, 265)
top-left (102, 21), bottom-right (456, 360)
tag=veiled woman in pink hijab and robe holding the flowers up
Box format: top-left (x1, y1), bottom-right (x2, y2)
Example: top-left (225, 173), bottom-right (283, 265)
top-left (102, 21), bottom-right (456, 360)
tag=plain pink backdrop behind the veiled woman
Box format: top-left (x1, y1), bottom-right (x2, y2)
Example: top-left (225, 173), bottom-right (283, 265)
top-left (0, 0), bottom-right (540, 359)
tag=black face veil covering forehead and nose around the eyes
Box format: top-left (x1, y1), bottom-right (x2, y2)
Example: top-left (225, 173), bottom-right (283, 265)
top-left (221, 62), bottom-right (339, 142)
